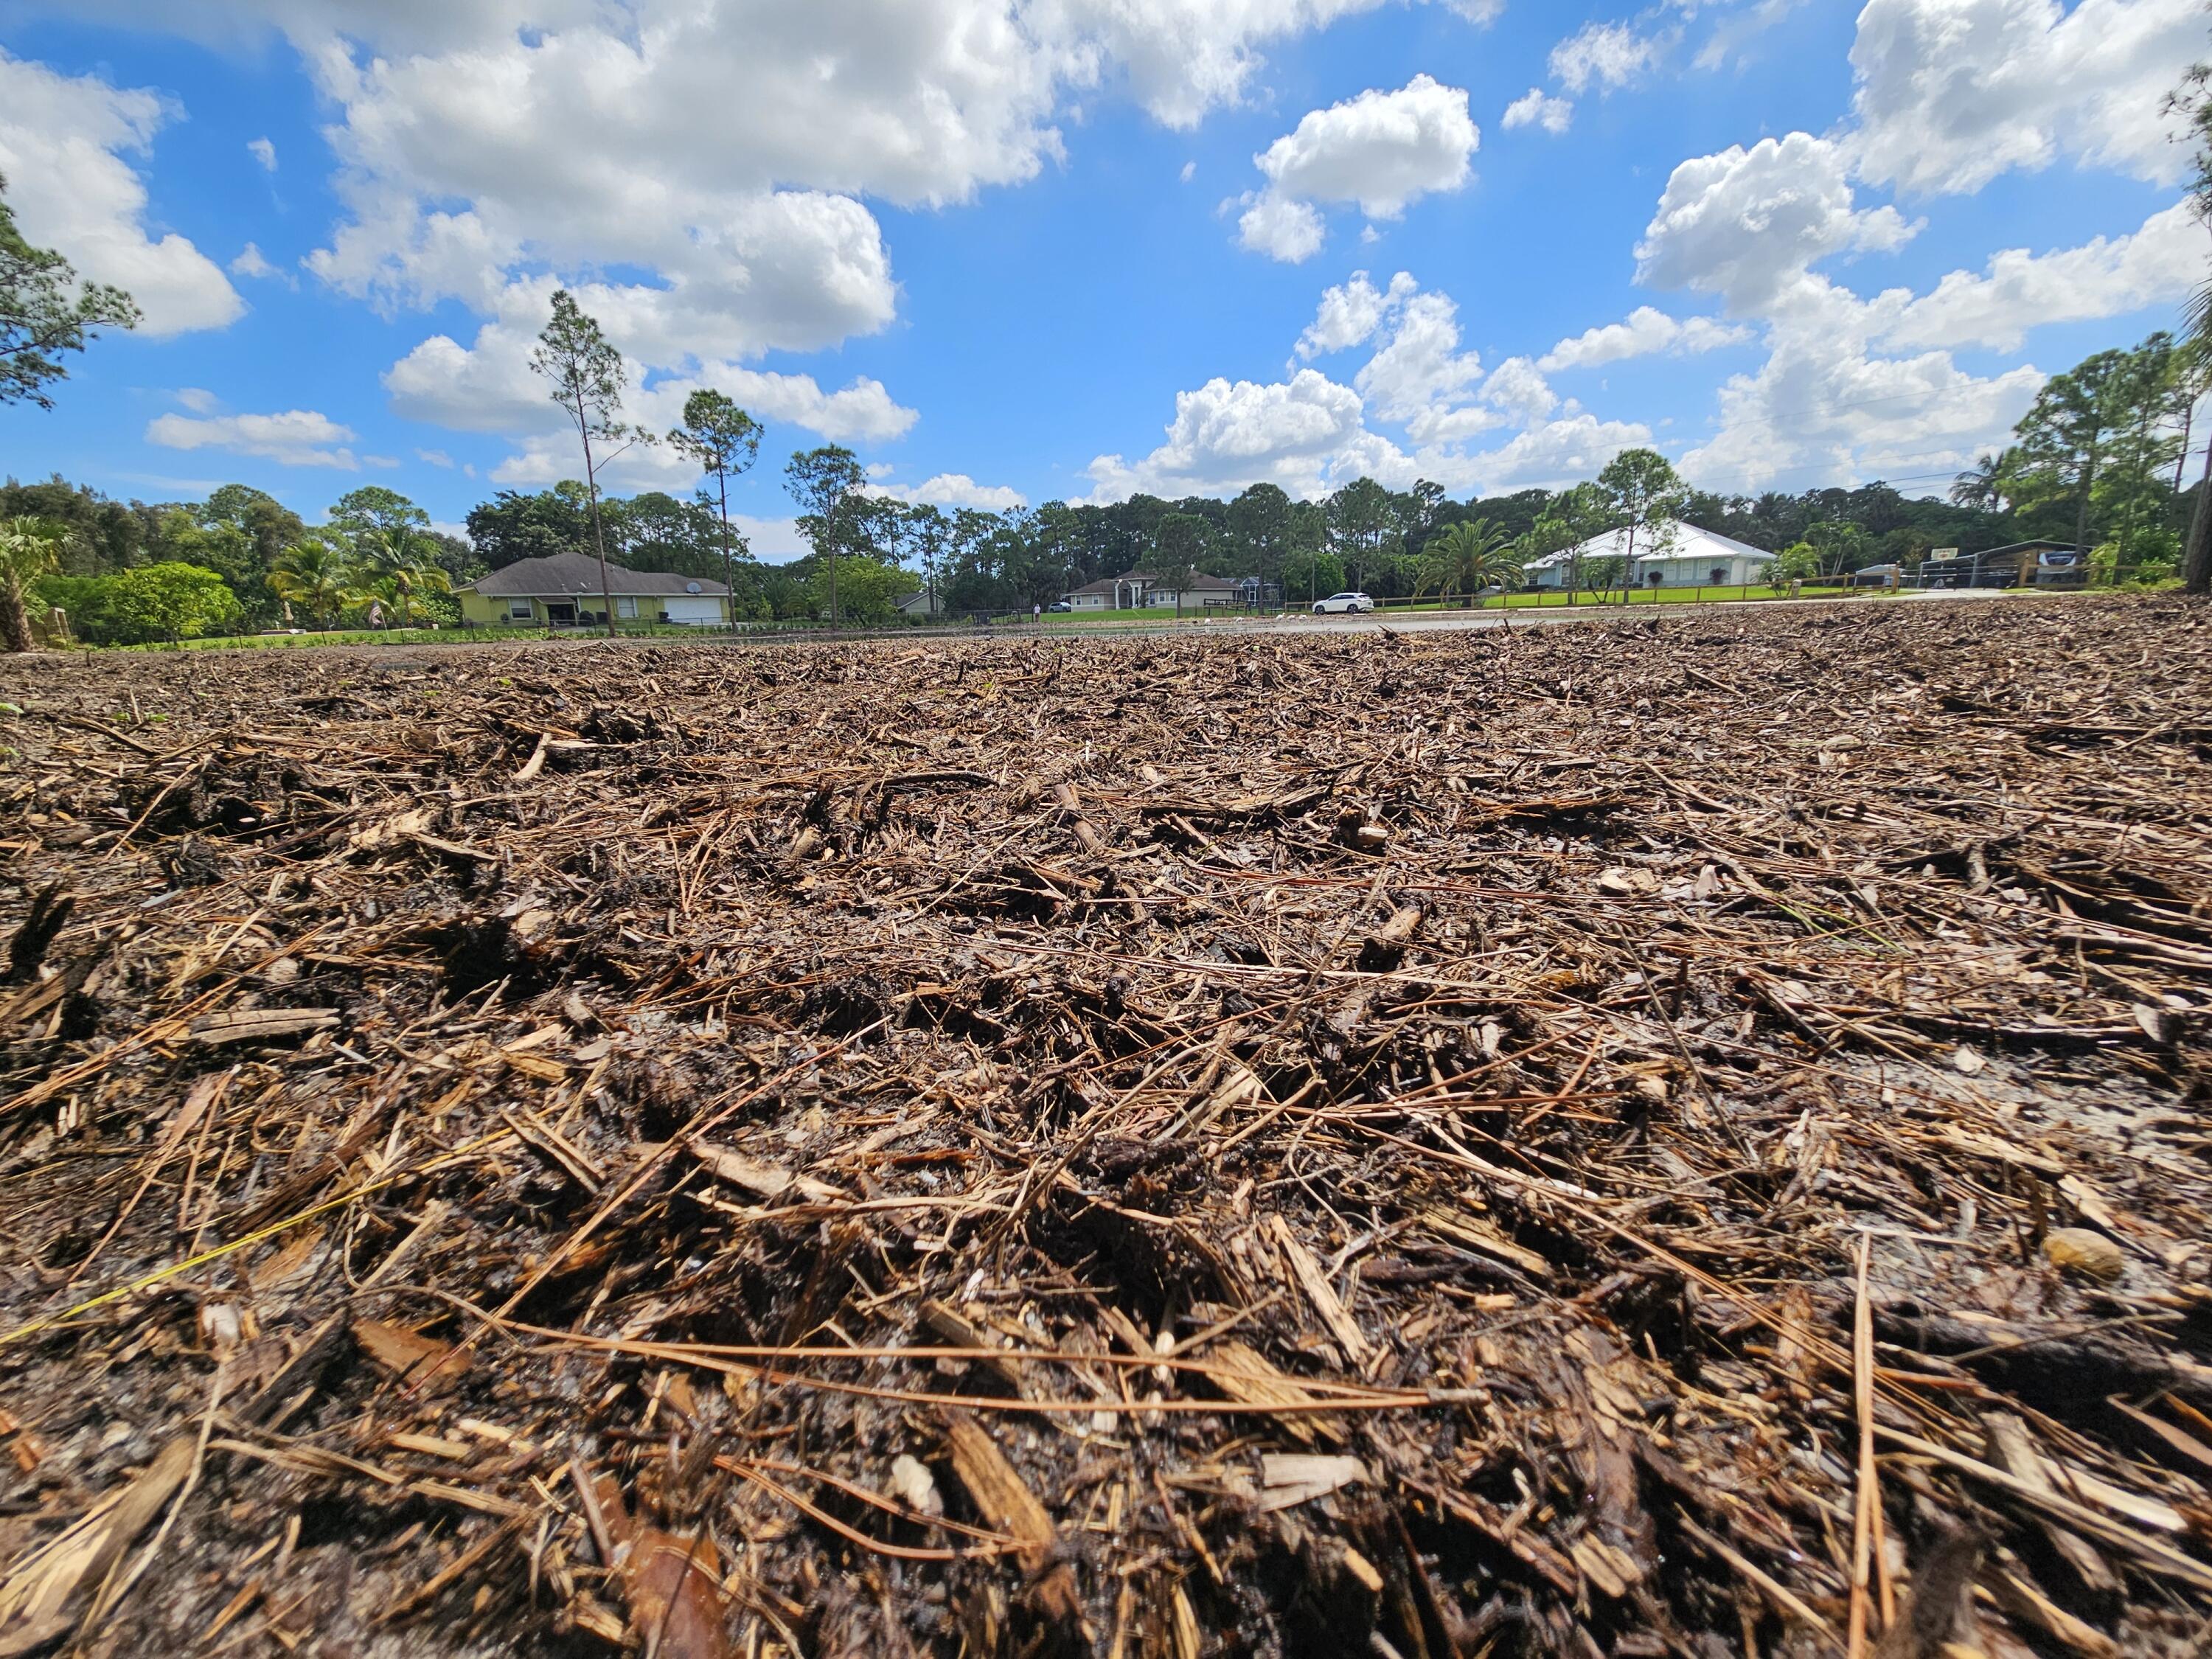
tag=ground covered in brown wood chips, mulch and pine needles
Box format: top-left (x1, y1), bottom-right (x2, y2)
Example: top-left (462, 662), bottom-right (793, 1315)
top-left (0, 599), bottom-right (2212, 1659)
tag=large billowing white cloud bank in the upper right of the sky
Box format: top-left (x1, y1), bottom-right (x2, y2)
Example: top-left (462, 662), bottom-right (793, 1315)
top-left (1628, 24), bottom-right (2203, 507)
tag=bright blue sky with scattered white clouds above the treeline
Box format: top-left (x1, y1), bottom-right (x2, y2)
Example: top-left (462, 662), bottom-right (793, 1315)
top-left (0, 0), bottom-right (2212, 557)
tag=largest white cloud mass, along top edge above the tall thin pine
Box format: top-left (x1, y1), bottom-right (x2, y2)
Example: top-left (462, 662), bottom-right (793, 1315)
top-left (285, 0), bottom-right (1491, 341)
